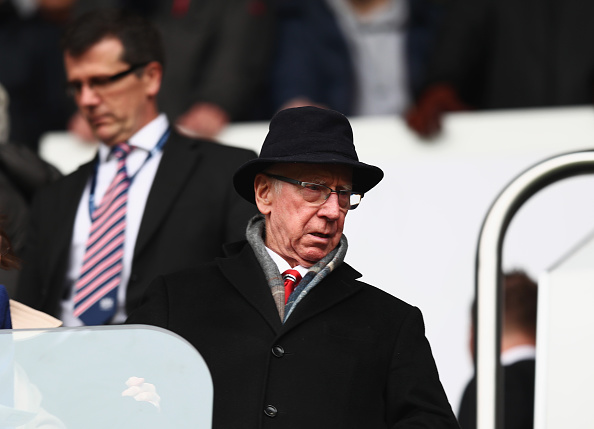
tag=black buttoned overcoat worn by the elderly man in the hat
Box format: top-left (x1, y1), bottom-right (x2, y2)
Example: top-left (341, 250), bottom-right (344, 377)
top-left (127, 242), bottom-right (458, 429)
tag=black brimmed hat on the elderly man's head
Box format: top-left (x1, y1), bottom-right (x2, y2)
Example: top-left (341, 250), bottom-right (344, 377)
top-left (233, 106), bottom-right (384, 204)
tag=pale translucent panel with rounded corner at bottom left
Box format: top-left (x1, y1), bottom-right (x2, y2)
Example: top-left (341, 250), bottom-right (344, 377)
top-left (0, 325), bottom-right (213, 429)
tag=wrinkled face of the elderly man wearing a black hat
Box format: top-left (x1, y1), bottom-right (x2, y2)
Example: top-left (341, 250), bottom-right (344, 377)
top-left (255, 164), bottom-right (352, 267)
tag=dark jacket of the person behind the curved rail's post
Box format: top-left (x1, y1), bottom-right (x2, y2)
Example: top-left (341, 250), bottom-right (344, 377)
top-left (458, 359), bottom-right (535, 429)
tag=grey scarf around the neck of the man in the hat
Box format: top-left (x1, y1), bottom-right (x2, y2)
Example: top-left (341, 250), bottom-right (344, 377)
top-left (245, 214), bottom-right (348, 323)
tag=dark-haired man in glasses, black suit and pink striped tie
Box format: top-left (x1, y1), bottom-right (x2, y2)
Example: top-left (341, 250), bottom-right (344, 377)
top-left (17, 10), bottom-right (255, 326)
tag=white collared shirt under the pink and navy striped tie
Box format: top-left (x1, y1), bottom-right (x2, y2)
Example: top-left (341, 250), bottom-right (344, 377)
top-left (60, 114), bottom-right (169, 326)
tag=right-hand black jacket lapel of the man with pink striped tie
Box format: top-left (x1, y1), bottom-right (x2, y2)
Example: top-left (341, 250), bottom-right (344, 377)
top-left (134, 132), bottom-right (201, 258)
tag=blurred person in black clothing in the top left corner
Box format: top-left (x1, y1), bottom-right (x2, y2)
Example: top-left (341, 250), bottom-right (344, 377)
top-left (0, 0), bottom-right (74, 152)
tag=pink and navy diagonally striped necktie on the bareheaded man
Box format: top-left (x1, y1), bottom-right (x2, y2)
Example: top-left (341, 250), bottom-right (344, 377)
top-left (74, 142), bottom-right (132, 325)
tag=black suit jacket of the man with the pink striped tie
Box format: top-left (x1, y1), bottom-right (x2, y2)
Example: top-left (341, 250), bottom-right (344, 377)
top-left (16, 133), bottom-right (256, 316)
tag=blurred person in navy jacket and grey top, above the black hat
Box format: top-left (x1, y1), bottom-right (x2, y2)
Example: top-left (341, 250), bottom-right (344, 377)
top-left (271, 0), bottom-right (441, 115)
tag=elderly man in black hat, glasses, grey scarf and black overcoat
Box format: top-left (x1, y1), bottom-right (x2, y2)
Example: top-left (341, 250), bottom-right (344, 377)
top-left (127, 107), bottom-right (458, 429)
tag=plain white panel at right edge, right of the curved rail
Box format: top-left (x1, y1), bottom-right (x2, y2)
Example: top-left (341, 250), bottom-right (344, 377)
top-left (534, 236), bottom-right (594, 429)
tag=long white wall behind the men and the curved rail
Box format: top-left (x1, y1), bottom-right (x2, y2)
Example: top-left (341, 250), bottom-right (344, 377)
top-left (41, 107), bottom-right (594, 411)
